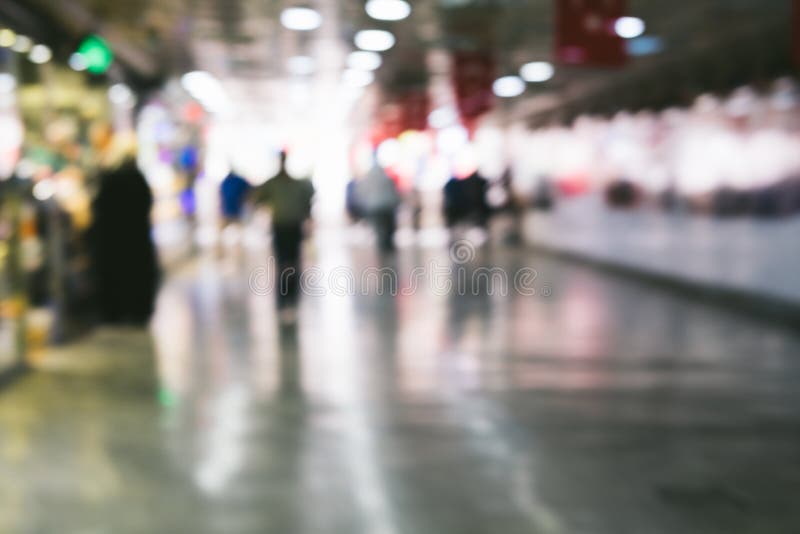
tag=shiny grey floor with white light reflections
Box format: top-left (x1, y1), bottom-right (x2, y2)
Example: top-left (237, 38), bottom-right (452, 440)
top-left (0, 231), bottom-right (800, 534)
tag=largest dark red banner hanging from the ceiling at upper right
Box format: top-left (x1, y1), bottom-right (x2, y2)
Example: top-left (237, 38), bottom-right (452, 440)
top-left (555, 0), bottom-right (628, 67)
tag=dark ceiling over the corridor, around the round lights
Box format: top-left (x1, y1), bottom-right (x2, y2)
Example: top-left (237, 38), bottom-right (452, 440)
top-left (0, 0), bottom-right (791, 125)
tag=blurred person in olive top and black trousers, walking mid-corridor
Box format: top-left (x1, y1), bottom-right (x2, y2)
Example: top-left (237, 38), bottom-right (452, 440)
top-left (253, 152), bottom-right (314, 316)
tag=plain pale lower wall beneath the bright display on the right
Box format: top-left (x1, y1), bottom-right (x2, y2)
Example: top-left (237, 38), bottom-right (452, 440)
top-left (525, 197), bottom-right (800, 304)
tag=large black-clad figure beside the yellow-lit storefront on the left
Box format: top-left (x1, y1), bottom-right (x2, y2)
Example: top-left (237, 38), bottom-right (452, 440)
top-left (90, 133), bottom-right (158, 325)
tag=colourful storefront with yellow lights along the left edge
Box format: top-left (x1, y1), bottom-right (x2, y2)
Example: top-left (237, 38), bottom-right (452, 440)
top-left (0, 28), bottom-right (150, 360)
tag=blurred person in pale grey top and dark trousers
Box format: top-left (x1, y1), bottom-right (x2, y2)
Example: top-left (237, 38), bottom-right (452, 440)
top-left (354, 159), bottom-right (400, 253)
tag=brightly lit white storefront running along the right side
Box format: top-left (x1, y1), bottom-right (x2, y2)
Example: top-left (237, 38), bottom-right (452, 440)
top-left (508, 78), bottom-right (800, 306)
